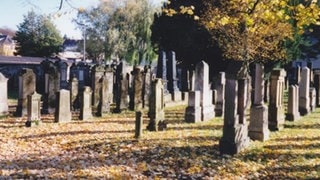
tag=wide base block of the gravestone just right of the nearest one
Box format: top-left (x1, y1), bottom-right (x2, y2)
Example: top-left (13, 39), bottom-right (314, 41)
top-left (249, 105), bottom-right (270, 141)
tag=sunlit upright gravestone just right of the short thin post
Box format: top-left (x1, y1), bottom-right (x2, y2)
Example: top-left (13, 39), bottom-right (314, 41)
top-left (147, 78), bottom-right (166, 131)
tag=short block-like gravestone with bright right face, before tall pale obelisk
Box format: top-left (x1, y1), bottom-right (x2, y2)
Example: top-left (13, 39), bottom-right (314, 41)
top-left (184, 91), bottom-right (201, 123)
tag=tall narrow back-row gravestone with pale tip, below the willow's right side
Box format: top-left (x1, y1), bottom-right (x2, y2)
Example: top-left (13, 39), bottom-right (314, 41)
top-left (115, 62), bottom-right (129, 112)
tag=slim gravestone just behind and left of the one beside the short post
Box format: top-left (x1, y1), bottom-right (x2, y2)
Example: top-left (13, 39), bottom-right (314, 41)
top-left (142, 66), bottom-right (152, 108)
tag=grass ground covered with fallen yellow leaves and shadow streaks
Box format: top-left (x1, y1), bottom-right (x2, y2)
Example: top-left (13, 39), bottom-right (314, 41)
top-left (0, 107), bottom-right (320, 179)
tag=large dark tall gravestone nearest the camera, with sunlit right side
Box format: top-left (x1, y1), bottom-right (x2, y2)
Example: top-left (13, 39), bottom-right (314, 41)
top-left (219, 61), bottom-right (250, 155)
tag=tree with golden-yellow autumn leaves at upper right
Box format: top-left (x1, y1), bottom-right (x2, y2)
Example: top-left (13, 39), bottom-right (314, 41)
top-left (161, 0), bottom-right (320, 72)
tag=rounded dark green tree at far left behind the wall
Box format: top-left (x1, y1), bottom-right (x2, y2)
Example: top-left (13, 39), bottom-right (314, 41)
top-left (14, 11), bottom-right (63, 57)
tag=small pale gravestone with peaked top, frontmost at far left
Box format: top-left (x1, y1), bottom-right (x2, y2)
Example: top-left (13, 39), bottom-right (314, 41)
top-left (26, 92), bottom-right (41, 127)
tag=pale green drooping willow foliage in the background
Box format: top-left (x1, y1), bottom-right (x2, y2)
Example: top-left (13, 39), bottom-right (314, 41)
top-left (76, 0), bottom-right (156, 64)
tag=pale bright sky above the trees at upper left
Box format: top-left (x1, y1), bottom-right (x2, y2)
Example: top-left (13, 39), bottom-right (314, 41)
top-left (0, 0), bottom-right (162, 39)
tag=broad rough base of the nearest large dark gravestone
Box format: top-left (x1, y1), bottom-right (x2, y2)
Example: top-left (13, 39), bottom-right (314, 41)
top-left (219, 124), bottom-right (250, 155)
